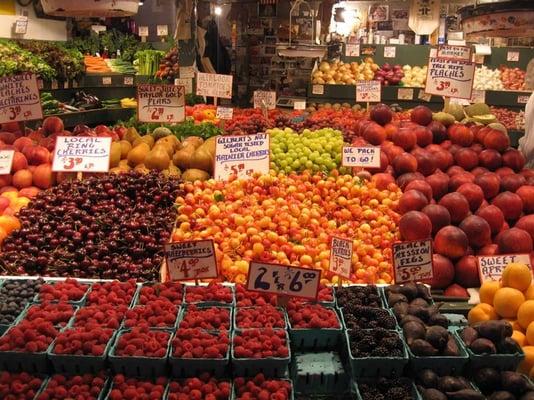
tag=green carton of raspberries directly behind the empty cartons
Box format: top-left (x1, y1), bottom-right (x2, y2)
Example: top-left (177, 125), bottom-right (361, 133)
top-left (287, 307), bottom-right (343, 350)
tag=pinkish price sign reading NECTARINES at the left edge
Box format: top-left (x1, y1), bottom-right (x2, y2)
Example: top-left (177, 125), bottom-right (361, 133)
top-left (0, 73), bottom-right (43, 123)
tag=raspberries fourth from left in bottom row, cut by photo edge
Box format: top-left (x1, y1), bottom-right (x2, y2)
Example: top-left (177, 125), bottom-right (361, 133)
top-left (167, 374), bottom-right (232, 400)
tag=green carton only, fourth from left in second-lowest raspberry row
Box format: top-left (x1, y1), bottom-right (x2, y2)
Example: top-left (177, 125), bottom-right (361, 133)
top-left (169, 331), bottom-right (232, 378)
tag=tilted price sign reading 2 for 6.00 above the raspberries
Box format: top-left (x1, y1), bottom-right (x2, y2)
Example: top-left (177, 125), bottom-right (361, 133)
top-left (247, 261), bottom-right (321, 299)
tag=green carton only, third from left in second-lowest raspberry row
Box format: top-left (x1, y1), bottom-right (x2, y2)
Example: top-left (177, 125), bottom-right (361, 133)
top-left (108, 329), bottom-right (173, 378)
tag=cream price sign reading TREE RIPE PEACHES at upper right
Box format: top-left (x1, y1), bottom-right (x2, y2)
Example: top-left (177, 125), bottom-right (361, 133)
top-left (425, 57), bottom-right (475, 100)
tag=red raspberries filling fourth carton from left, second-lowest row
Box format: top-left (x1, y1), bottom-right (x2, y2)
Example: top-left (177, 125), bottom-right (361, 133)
top-left (172, 328), bottom-right (230, 358)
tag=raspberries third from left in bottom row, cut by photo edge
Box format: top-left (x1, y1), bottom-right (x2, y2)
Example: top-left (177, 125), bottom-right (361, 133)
top-left (108, 374), bottom-right (167, 400)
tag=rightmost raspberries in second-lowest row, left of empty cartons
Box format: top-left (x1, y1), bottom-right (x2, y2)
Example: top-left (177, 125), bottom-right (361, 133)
top-left (233, 328), bottom-right (289, 358)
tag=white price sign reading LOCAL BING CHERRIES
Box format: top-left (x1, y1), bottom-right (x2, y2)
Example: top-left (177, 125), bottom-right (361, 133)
top-left (52, 136), bottom-right (111, 172)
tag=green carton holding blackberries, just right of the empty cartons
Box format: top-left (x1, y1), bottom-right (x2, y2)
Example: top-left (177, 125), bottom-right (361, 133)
top-left (345, 330), bottom-right (409, 379)
